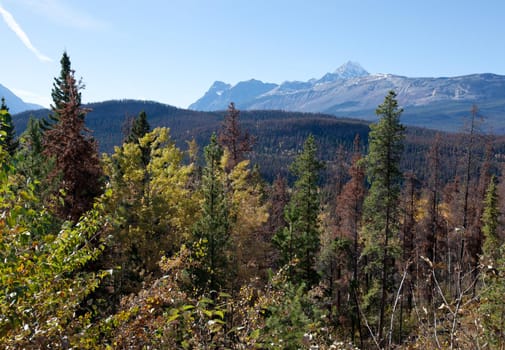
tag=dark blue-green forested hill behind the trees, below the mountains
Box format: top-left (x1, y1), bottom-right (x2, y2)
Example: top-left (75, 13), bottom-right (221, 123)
top-left (13, 100), bottom-right (505, 181)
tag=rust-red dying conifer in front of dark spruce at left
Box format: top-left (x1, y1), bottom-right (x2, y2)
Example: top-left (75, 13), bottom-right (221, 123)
top-left (43, 72), bottom-right (102, 222)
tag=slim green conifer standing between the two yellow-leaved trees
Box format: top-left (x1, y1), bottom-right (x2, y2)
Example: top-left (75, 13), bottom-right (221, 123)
top-left (193, 134), bottom-right (231, 291)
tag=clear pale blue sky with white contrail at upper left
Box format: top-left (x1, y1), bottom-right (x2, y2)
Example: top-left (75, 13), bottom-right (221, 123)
top-left (0, 0), bottom-right (505, 108)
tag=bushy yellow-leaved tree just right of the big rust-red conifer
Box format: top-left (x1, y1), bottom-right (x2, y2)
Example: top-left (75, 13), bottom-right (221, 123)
top-left (96, 128), bottom-right (198, 306)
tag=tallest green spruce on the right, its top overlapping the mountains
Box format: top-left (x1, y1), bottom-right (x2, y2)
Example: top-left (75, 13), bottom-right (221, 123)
top-left (363, 91), bottom-right (405, 342)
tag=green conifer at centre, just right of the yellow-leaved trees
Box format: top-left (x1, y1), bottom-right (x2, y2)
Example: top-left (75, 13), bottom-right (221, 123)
top-left (274, 135), bottom-right (323, 286)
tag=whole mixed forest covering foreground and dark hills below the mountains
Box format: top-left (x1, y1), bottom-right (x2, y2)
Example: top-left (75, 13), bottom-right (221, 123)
top-left (0, 53), bottom-right (505, 349)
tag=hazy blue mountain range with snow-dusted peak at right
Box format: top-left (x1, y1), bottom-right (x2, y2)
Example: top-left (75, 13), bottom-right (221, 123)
top-left (189, 62), bottom-right (505, 133)
